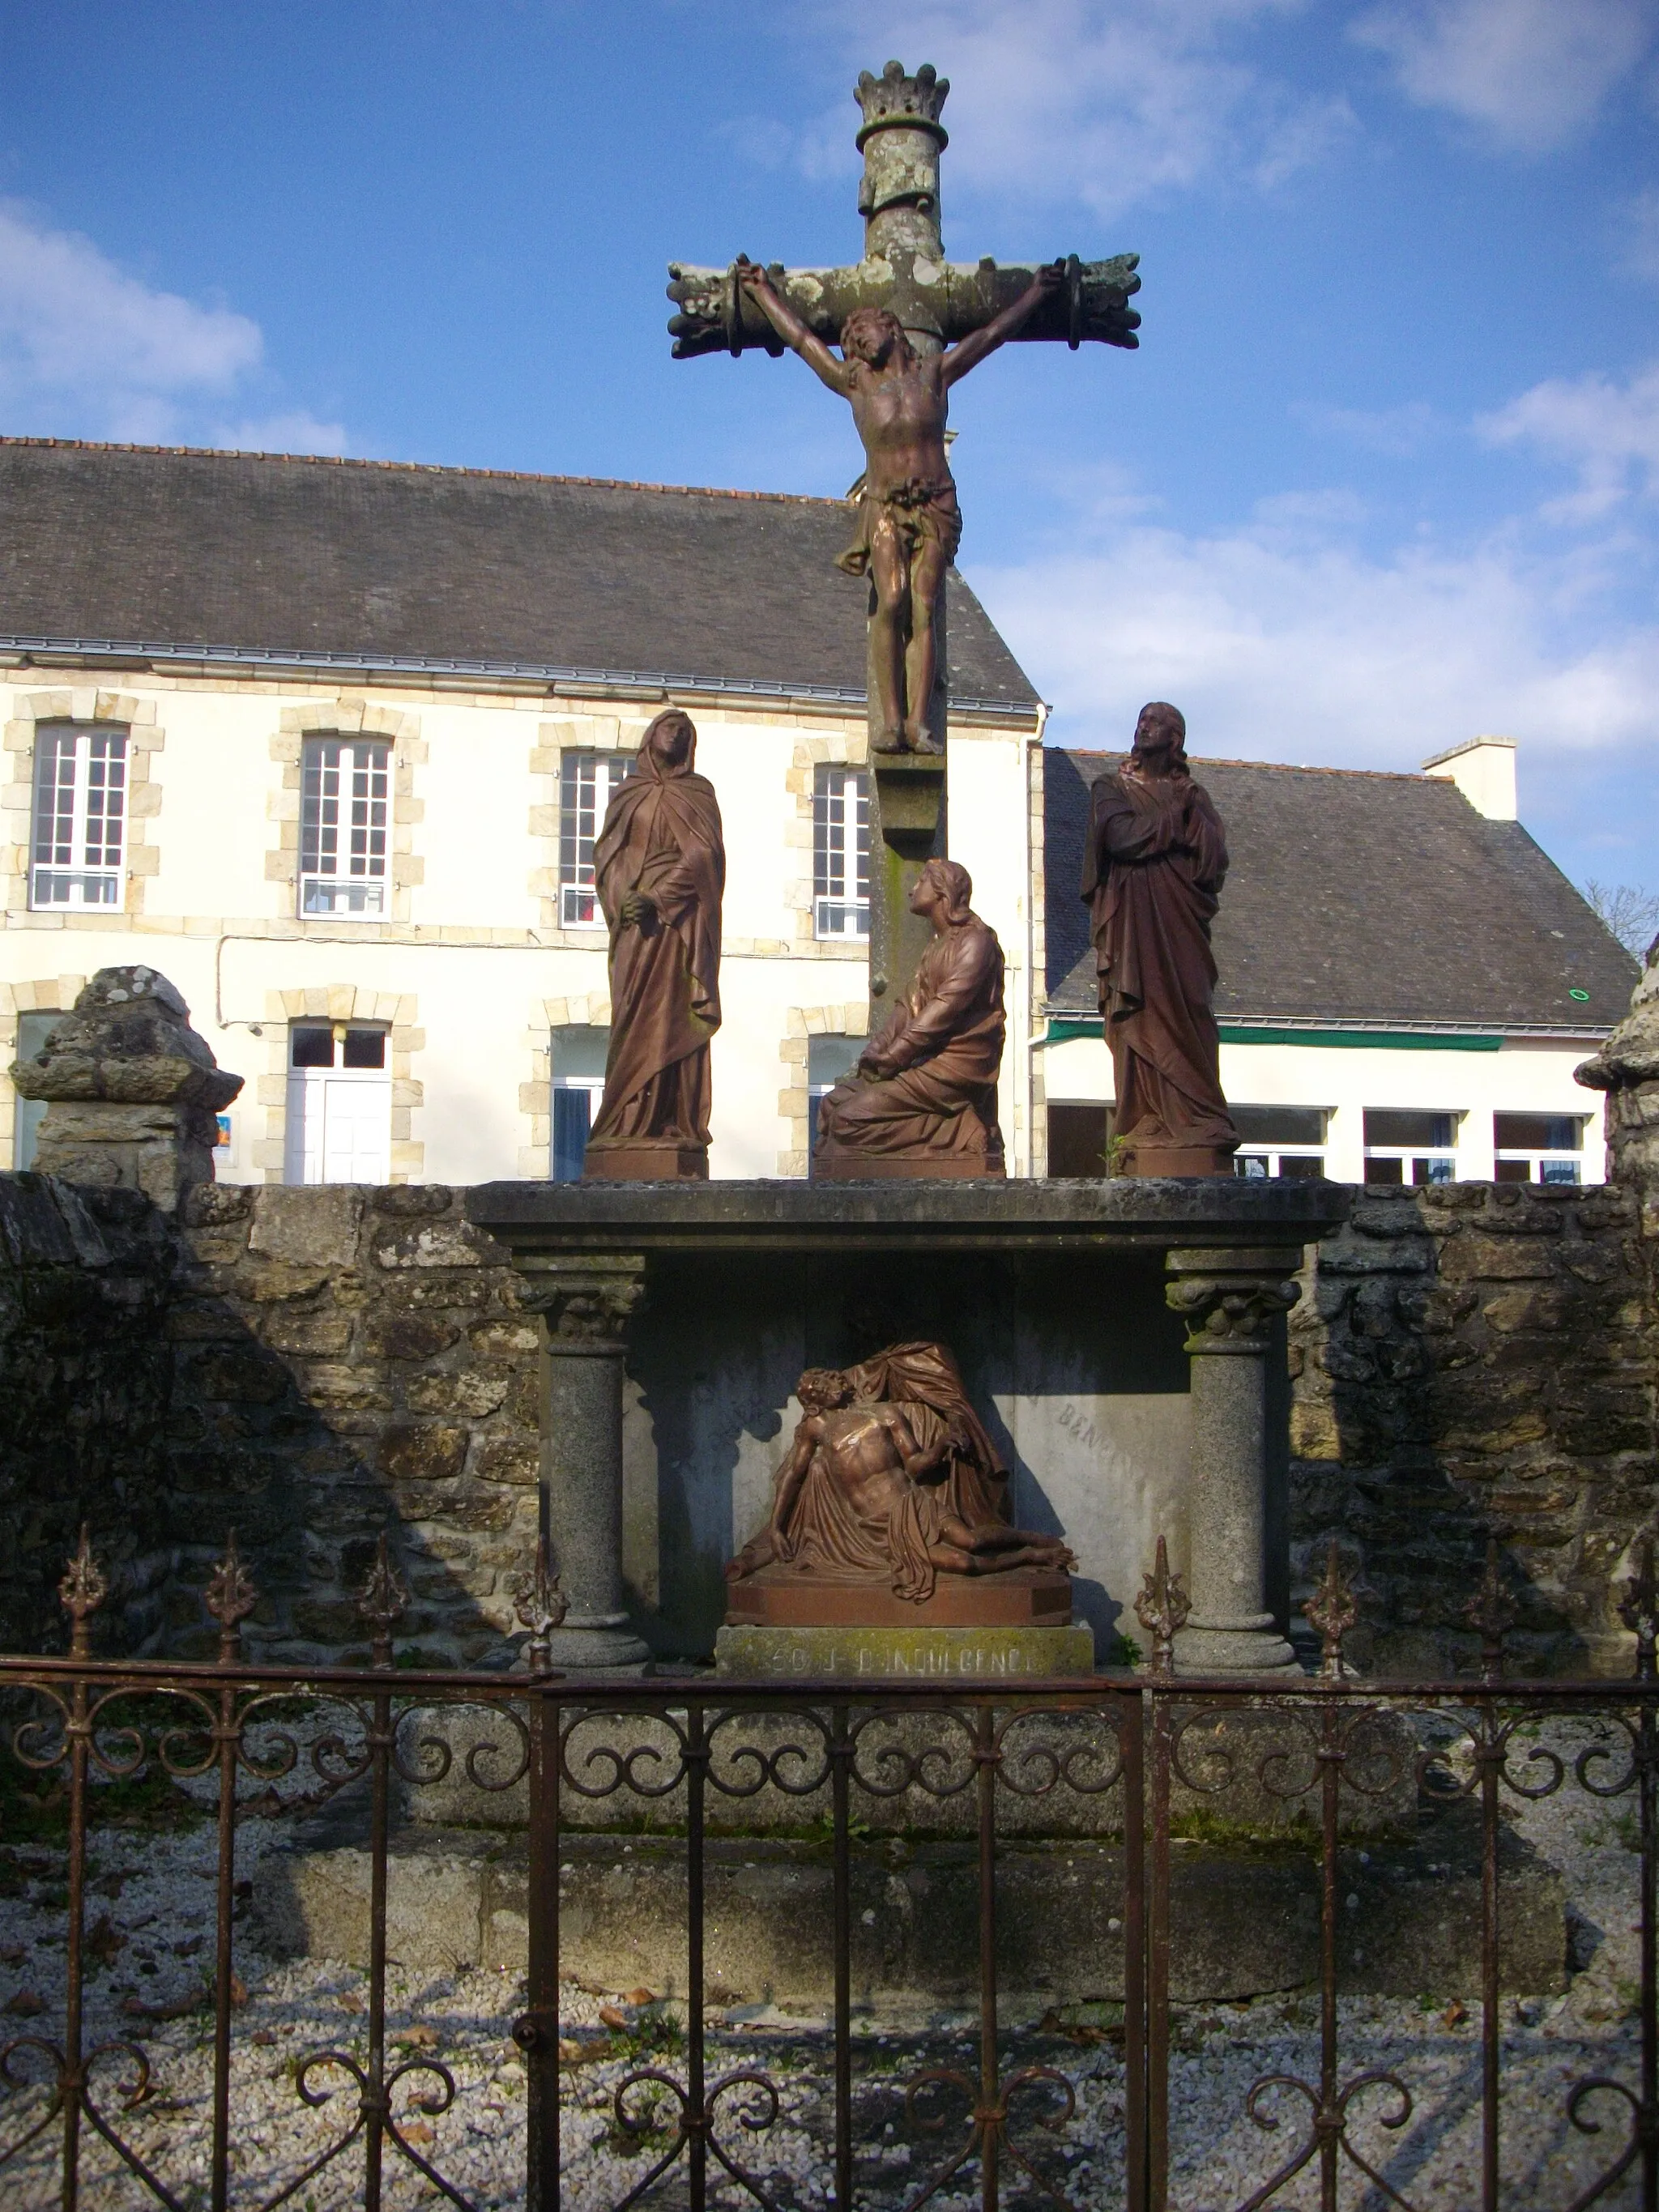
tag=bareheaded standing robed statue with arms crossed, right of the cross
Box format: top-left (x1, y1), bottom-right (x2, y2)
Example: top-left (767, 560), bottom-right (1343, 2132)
top-left (1081, 699), bottom-right (1239, 1174)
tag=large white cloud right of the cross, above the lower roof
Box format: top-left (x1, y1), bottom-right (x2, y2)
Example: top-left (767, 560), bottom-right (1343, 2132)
top-left (971, 514), bottom-right (1659, 768)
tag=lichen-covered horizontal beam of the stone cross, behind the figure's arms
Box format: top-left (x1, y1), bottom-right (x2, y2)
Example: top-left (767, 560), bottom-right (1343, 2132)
top-left (668, 254), bottom-right (1141, 360)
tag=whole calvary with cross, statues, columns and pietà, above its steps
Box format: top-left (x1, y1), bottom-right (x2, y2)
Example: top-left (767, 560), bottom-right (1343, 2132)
top-left (467, 62), bottom-right (1350, 1679)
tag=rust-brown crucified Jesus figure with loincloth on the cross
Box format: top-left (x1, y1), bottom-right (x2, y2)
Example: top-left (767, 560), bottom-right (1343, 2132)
top-left (736, 259), bottom-right (1068, 752)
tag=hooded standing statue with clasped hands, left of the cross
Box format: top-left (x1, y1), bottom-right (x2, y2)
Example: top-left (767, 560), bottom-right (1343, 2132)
top-left (582, 708), bottom-right (726, 1181)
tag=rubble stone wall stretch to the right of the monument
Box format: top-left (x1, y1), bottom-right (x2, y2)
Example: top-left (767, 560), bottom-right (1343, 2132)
top-left (1290, 1183), bottom-right (1659, 1677)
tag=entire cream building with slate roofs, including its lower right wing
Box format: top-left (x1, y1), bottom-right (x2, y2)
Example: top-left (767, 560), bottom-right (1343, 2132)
top-left (0, 438), bottom-right (1635, 1183)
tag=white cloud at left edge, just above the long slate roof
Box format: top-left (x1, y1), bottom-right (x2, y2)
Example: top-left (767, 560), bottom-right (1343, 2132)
top-left (0, 199), bottom-right (345, 454)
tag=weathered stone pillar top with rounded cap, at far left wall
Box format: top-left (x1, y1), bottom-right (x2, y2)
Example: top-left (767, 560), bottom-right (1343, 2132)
top-left (11, 966), bottom-right (241, 1214)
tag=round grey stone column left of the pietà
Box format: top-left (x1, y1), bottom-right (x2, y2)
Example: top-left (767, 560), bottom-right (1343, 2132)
top-left (520, 1252), bottom-right (650, 1673)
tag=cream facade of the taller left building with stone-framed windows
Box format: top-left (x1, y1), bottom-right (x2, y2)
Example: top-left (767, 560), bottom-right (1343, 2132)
top-left (0, 668), bottom-right (1042, 1183)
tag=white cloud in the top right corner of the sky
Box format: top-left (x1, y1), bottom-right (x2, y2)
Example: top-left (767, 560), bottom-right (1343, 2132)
top-left (1354, 0), bottom-right (1655, 152)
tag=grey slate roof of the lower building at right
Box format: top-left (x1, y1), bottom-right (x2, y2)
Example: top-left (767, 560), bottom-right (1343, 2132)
top-left (1044, 745), bottom-right (1637, 1031)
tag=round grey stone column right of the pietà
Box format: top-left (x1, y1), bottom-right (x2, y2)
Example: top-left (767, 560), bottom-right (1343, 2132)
top-left (1166, 1247), bottom-right (1299, 1674)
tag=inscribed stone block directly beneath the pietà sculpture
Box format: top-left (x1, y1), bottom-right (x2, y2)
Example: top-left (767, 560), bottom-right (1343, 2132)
top-left (714, 1622), bottom-right (1095, 1681)
